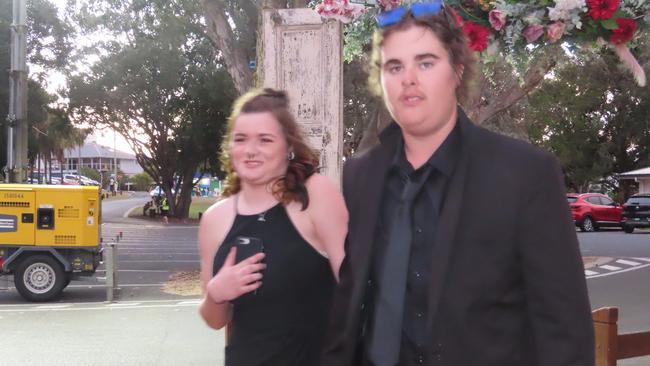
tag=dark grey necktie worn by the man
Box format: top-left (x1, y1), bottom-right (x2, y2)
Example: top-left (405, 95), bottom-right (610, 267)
top-left (368, 164), bottom-right (431, 366)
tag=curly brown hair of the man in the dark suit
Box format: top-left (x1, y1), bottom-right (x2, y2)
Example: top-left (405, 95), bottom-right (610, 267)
top-left (368, 7), bottom-right (476, 103)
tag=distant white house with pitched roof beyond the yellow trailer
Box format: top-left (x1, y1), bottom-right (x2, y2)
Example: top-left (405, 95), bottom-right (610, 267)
top-left (63, 141), bottom-right (143, 176)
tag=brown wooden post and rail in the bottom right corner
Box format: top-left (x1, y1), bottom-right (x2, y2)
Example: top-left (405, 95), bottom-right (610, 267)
top-left (591, 307), bottom-right (650, 366)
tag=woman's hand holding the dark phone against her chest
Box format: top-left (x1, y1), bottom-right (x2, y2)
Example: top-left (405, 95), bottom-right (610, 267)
top-left (207, 247), bottom-right (266, 304)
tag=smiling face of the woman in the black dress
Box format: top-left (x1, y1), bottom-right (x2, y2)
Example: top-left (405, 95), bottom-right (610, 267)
top-left (230, 112), bottom-right (288, 186)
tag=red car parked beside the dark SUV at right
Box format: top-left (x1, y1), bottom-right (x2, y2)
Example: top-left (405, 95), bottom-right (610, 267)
top-left (567, 193), bottom-right (623, 231)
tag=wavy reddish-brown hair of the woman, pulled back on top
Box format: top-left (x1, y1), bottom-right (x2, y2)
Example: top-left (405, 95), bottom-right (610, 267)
top-left (219, 88), bottom-right (319, 210)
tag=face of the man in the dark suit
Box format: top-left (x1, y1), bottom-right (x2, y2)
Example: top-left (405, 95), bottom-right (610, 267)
top-left (381, 26), bottom-right (459, 136)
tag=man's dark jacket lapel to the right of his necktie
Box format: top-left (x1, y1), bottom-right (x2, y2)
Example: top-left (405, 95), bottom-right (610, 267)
top-left (427, 108), bottom-right (476, 329)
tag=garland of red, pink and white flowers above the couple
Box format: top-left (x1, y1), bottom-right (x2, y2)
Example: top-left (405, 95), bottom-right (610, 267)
top-left (315, 0), bottom-right (650, 86)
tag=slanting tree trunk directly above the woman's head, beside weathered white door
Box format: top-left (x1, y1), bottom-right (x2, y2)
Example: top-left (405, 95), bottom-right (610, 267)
top-left (201, 0), bottom-right (253, 94)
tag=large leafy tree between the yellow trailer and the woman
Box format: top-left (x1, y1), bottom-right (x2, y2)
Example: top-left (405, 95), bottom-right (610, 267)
top-left (70, 0), bottom-right (236, 216)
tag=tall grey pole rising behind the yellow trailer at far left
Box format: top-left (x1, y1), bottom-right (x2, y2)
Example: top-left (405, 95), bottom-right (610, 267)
top-left (4, 0), bottom-right (28, 182)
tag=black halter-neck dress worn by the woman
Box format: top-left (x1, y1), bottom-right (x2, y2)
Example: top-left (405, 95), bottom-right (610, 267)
top-left (213, 204), bottom-right (336, 366)
